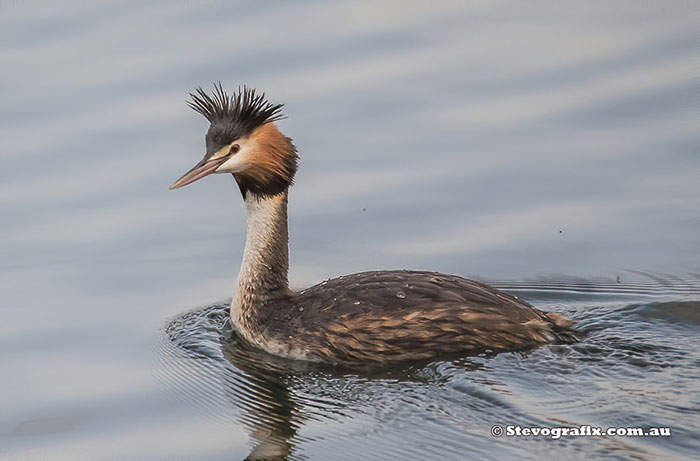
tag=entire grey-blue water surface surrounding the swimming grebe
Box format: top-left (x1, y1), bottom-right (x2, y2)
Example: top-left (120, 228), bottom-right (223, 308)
top-left (0, 1), bottom-right (700, 460)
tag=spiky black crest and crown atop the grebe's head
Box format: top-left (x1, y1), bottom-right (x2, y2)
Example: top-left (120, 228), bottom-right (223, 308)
top-left (187, 82), bottom-right (284, 155)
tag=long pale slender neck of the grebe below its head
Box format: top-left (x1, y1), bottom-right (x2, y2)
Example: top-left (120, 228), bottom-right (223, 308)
top-left (231, 190), bottom-right (289, 329)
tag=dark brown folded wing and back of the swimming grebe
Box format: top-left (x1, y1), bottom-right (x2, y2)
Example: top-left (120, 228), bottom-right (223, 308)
top-left (294, 271), bottom-right (573, 362)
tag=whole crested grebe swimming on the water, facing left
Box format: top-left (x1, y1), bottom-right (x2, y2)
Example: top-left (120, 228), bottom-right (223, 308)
top-left (170, 83), bottom-right (576, 365)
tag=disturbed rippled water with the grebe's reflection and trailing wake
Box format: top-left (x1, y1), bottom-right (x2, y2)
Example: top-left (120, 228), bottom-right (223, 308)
top-left (159, 279), bottom-right (700, 459)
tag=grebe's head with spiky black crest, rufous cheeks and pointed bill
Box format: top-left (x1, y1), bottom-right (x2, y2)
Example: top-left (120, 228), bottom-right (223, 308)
top-left (170, 83), bottom-right (299, 197)
